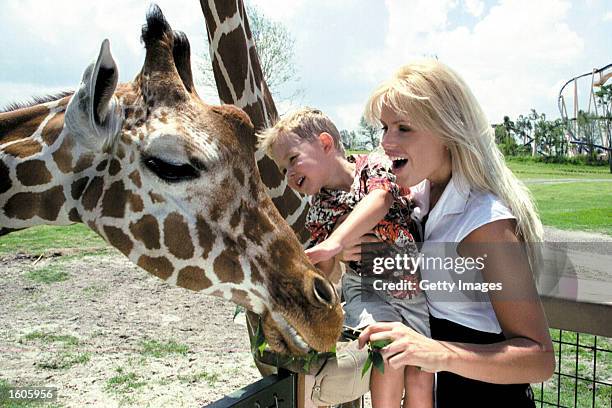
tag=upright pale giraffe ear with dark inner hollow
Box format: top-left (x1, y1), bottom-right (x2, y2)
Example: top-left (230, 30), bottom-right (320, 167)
top-left (65, 40), bottom-right (123, 150)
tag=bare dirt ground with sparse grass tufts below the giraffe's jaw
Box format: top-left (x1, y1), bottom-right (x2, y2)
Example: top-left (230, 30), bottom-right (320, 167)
top-left (0, 252), bottom-right (259, 407)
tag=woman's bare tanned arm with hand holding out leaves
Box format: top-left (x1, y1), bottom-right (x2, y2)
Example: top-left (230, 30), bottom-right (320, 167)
top-left (359, 220), bottom-right (555, 384)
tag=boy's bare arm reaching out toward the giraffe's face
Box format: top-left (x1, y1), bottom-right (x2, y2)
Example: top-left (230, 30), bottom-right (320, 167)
top-left (306, 189), bottom-right (393, 264)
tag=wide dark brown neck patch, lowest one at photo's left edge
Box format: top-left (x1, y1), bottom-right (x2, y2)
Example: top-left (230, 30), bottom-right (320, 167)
top-left (4, 186), bottom-right (66, 221)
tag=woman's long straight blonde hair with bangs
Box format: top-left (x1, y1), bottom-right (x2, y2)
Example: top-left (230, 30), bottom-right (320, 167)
top-left (365, 59), bottom-right (543, 272)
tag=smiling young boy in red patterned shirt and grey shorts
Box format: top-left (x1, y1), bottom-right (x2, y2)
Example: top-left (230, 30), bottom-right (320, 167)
top-left (258, 108), bottom-right (433, 408)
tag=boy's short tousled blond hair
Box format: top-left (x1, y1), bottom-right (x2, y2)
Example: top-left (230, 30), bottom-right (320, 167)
top-left (257, 107), bottom-right (344, 157)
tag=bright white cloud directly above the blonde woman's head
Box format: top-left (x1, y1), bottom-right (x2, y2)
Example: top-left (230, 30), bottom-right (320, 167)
top-left (352, 0), bottom-right (584, 121)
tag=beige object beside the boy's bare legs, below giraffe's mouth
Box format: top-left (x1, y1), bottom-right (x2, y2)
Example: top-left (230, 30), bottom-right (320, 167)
top-left (311, 340), bottom-right (371, 405)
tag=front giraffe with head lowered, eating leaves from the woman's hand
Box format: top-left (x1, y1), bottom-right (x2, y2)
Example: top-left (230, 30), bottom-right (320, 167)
top-left (0, 6), bottom-right (342, 354)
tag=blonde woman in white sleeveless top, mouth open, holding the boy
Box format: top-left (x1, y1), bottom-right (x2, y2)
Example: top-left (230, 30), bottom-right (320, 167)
top-left (354, 60), bottom-right (555, 408)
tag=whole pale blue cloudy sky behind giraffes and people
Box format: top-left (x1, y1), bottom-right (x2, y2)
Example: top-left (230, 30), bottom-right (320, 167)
top-left (0, 0), bottom-right (612, 129)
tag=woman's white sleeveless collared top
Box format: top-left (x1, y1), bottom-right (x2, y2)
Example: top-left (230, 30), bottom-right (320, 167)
top-left (417, 175), bottom-right (515, 333)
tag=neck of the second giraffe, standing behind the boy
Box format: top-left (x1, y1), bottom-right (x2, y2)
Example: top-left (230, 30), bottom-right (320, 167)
top-left (200, 0), bottom-right (308, 241)
